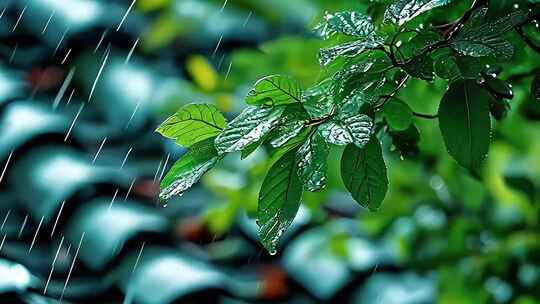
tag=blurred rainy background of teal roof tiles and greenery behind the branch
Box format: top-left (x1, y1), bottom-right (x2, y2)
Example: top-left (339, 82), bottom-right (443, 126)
top-left (0, 0), bottom-right (540, 304)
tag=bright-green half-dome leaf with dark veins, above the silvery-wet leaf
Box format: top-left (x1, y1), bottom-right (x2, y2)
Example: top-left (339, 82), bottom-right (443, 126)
top-left (245, 75), bottom-right (302, 106)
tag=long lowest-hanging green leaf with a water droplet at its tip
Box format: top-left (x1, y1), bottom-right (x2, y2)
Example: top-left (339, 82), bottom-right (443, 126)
top-left (257, 149), bottom-right (302, 254)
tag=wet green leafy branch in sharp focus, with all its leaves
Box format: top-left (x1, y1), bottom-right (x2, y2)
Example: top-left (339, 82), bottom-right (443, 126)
top-left (157, 0), bottom-right (539, 253)
